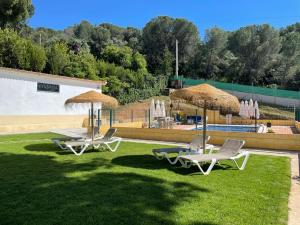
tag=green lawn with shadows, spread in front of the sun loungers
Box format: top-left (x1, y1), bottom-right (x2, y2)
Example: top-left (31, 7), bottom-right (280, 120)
top-left (0, 134), bottom-right (290, 225)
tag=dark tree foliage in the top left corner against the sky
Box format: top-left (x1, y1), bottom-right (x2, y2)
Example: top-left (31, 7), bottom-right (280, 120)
top-left (0, 0), bottom-right (34, 28)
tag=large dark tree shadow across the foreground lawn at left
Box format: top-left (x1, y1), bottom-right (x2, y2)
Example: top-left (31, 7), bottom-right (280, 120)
top-left (0, 154), bottom-right (218, 225)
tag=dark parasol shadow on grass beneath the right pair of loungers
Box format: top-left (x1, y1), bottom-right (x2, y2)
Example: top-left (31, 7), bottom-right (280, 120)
top-left (112, 155), bottom-right (234, 175)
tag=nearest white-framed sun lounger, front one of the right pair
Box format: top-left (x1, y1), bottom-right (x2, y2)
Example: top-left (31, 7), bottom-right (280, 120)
top-left (179, 139), bottom-right (249, 175)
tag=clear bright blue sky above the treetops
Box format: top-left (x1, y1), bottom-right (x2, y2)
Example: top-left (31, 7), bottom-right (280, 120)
top-left (29, 0), bottom-right (300, 37)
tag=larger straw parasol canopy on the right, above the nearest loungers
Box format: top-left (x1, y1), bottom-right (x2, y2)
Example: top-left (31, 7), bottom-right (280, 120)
top-left (170, 84), bottom-right (240, 114)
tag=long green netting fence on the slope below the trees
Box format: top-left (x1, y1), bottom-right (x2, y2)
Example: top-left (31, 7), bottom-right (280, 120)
top-left (172, 76), bottom-right (300, 99)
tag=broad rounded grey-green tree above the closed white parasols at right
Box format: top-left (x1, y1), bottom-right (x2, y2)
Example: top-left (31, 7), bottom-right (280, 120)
top-left (229, 24), bottom-right (281, 84)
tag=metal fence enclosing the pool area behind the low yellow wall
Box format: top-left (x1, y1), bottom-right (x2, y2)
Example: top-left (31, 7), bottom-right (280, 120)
top-left (97, 103), bottom-right (298, 134)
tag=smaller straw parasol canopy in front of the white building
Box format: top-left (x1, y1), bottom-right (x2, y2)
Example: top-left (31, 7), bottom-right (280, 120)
top-left (65, 91), bottom-right (118, 108)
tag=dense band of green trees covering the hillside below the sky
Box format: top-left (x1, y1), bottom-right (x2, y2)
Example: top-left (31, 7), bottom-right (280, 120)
top-left (0, 0), bottom-right (300, 103)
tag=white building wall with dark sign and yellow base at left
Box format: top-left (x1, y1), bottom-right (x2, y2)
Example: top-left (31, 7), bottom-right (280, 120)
top-left (0, 67), bottom-right (106, 132)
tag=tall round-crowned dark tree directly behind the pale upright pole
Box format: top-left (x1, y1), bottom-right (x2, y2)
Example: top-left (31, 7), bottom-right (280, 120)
top-left (142, 16), bottom-right (199, 73)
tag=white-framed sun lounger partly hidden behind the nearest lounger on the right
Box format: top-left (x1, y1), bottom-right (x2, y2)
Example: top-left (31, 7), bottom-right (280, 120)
top-left (152, 136), bottom-right (214, 165)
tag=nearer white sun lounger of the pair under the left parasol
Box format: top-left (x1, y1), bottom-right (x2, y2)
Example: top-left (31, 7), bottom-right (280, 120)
top-left (65, 128), bottom-right (122, 155)
